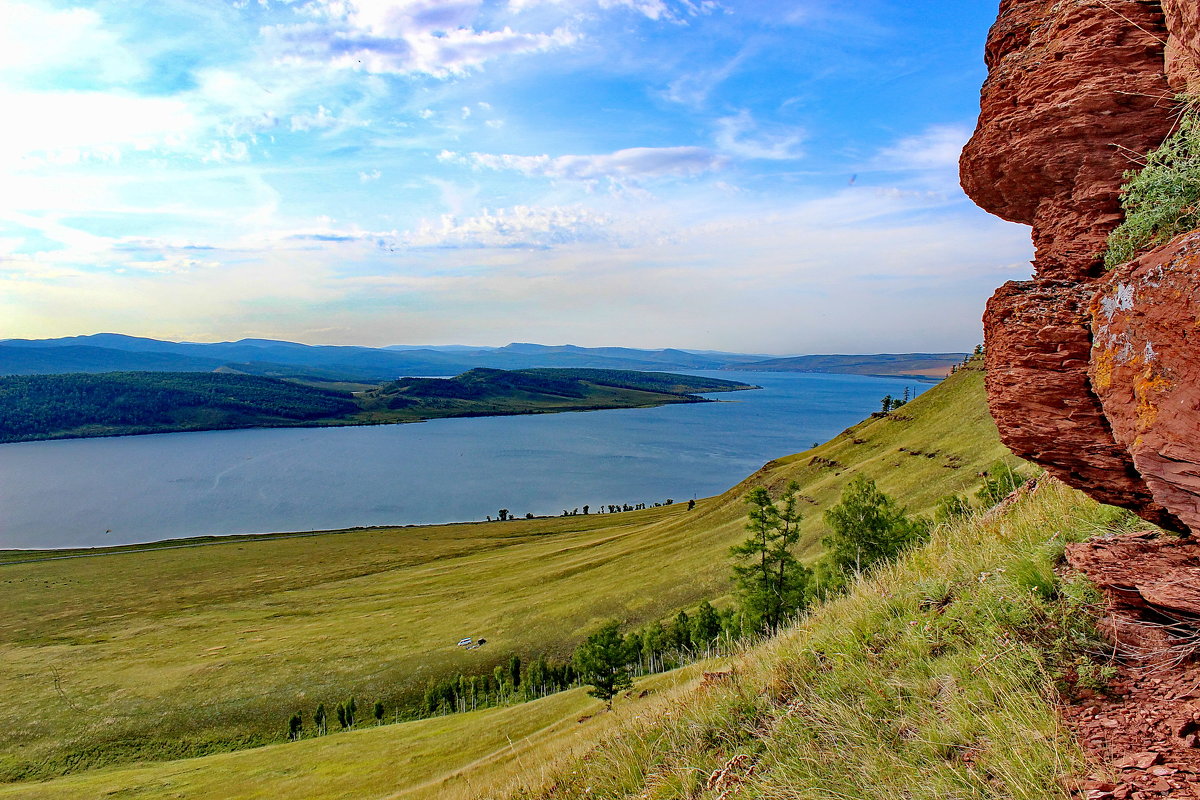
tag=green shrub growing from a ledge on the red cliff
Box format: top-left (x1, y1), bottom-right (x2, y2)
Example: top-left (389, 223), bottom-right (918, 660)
top-left (1104, 100), bottom-right (1200, 269)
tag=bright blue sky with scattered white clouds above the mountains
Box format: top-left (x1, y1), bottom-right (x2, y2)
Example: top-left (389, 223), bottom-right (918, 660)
top-left (0, 0), bottom-right (1032, 354)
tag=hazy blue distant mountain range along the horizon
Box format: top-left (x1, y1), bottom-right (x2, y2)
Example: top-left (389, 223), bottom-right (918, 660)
top-left (0, 333), bottom-right (966, 383)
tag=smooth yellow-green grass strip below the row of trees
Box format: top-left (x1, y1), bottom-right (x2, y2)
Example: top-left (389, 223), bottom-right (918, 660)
top-left (0, 666), bottom-right (701, 800)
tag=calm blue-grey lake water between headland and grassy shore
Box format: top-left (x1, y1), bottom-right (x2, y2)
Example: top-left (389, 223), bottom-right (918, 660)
top-left (0, 372), bottom-right (928, 548)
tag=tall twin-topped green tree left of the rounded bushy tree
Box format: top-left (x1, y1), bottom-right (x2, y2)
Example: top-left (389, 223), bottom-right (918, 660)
top-left (730, 481), bottom-right (812, 632)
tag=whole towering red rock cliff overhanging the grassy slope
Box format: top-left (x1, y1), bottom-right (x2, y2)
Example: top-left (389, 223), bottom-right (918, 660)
top-left (961, 0), bottom-right (1200, 533)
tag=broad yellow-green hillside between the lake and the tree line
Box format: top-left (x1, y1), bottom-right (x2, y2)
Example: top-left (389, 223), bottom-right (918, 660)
top-left (0, 371), bottom-right (1006, 777)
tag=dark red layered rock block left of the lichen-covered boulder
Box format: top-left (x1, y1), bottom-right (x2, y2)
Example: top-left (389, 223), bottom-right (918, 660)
top-left (984, 279), bottom-right (1178, 527)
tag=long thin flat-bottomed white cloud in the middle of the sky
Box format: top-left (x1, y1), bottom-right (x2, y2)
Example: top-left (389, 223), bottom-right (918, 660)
top-left (438, 146), bottom-right (727, 184)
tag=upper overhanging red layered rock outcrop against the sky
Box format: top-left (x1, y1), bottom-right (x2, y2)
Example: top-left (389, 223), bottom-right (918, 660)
top-left (961, 0), bottom-right (1170, 281)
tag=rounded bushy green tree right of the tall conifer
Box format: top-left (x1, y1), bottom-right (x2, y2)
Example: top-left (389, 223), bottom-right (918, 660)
top-left (822, 475), bottom-right (929, 573)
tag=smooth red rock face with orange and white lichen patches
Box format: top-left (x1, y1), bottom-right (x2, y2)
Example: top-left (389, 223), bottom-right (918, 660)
top-left (1090, 231), bottom-right (1200, 533)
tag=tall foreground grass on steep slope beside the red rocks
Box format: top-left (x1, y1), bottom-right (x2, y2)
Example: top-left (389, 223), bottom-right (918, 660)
top-left (520, 480), bottom-right (1145, 800)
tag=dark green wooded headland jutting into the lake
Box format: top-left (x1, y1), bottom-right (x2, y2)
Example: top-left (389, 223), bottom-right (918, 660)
top-left (0, 368), bottom-right (758, 444)
